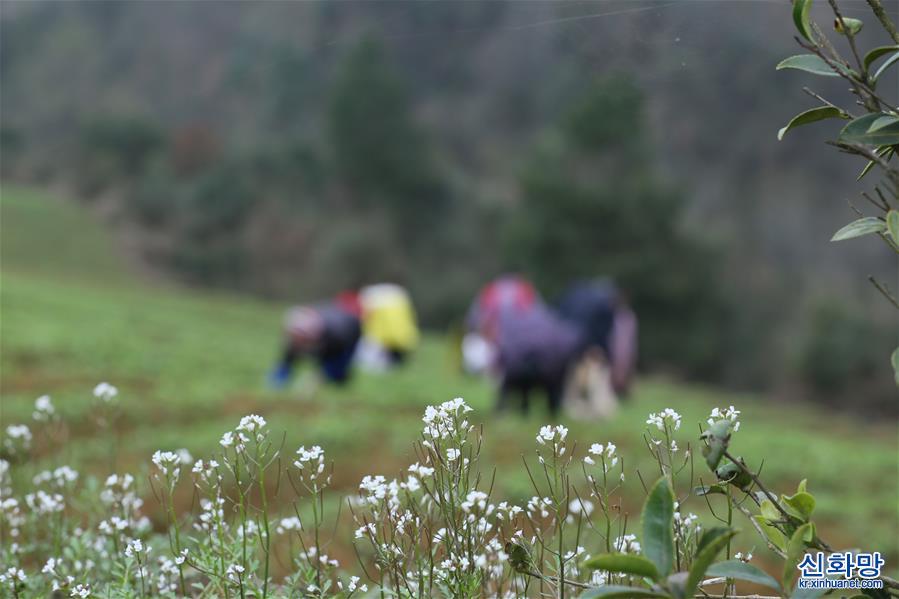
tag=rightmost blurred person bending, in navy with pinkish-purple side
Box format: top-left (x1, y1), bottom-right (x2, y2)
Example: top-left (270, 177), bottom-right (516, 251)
top-left (558, 279), bottom-right (637, 397)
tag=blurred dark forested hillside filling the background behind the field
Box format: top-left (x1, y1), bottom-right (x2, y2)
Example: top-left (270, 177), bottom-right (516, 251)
top-left (0, 1), bottom-right (899, 402)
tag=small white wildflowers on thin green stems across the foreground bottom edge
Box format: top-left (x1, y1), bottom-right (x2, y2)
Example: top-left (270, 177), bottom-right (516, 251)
top-left (0, 383), bottom-right (776, 599)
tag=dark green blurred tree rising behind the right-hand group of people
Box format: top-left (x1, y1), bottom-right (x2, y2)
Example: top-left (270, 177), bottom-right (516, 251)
top-left (506, 76), bottom-right (726, 376)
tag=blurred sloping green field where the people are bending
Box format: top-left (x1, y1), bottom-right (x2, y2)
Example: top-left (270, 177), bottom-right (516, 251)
top-left (0, 185), bottom-right (899, 571)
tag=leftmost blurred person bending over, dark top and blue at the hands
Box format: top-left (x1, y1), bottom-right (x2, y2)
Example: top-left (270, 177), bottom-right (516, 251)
top-left (269, 300), bottom-right (361, 388)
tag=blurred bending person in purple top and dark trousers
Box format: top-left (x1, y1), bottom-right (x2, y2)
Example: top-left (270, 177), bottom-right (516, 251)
top-left (496, 304), bottom-right (585, 417)
